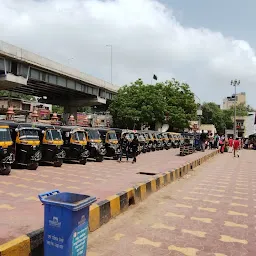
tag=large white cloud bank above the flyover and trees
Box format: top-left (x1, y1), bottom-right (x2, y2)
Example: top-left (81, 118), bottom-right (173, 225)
top-left (0, 0), bottom-right (256, 106)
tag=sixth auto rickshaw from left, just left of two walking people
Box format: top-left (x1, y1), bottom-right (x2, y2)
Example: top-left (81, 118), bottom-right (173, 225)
top-left (99, 128), bottom-right (121, 160)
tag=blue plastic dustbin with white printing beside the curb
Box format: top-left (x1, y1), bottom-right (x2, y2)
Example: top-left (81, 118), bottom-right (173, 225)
top-left (38, 190), bottom-right (96, 256)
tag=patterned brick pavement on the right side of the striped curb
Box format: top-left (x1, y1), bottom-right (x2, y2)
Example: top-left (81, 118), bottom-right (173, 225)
top-left (87, 150), bottom-right (256, 256)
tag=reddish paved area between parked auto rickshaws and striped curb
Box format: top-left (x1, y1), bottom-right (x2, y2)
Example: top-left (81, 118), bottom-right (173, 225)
top-left (0, 149), bottom-right (210, 244)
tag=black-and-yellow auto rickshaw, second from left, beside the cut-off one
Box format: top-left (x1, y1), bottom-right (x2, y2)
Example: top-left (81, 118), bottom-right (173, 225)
top-left (9, 122), bottom-right (42, 170)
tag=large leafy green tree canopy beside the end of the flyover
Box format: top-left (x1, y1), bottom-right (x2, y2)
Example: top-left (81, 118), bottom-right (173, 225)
top-left (109, 79), bottom-right (197, 130)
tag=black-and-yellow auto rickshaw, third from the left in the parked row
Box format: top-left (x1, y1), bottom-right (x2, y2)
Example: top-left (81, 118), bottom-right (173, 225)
top-left (35, 123), bottom-right (66, 167)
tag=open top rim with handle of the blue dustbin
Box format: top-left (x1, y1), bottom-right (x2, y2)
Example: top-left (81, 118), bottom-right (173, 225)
top-left (38, 190), bottom-right (96, 211)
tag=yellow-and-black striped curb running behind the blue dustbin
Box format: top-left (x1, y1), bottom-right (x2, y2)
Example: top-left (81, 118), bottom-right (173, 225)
top-left (0, 150), bottom-right (219, 256)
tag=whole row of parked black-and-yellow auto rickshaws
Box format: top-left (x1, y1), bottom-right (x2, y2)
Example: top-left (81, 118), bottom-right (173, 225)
top-left (0, 121), bottom-right (180, 175)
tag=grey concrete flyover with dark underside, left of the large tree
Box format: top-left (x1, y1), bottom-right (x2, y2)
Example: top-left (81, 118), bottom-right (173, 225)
top-left (0, 40), bottom-right (119, 112)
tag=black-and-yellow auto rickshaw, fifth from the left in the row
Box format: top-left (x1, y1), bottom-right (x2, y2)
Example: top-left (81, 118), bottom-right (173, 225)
top-left (84, 127), bottom-right (107, 162)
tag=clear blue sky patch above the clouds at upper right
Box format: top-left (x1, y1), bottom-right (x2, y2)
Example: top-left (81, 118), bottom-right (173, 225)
top-left (161, 0), bottom-right (256, 48)
